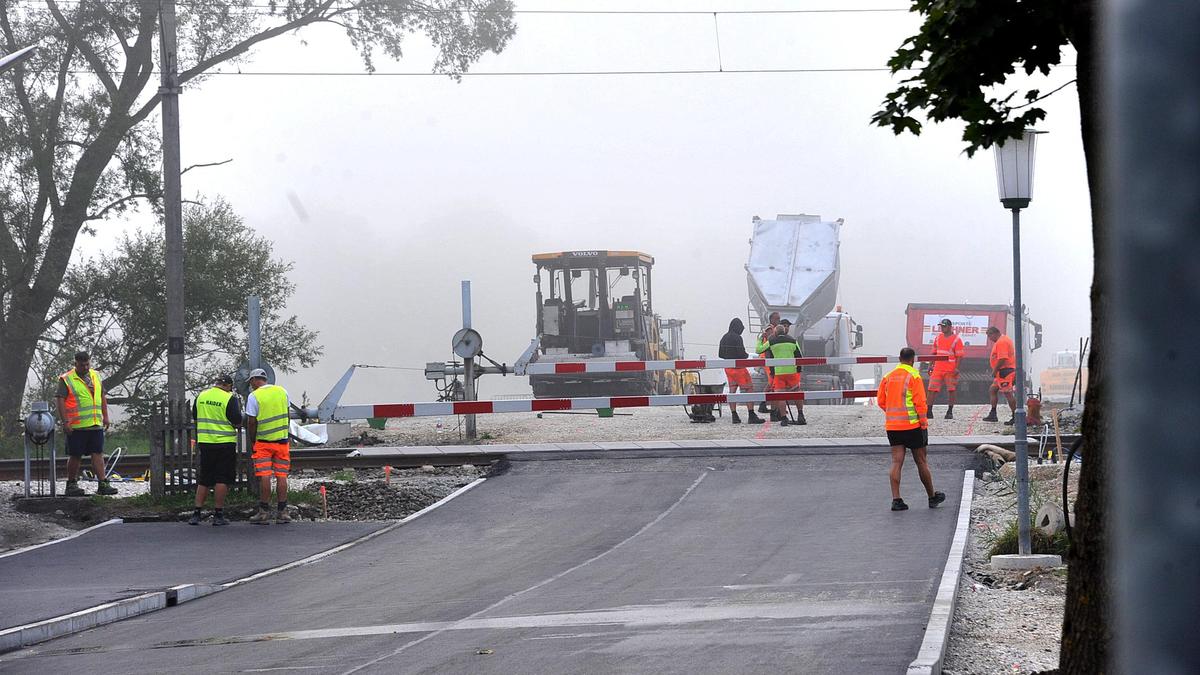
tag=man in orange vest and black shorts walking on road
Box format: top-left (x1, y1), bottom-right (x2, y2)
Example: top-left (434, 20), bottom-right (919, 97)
top-left (876, 347), bottom-right (946, 510)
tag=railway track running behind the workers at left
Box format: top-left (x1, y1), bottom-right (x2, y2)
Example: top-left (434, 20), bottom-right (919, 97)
top-left (0, 447), bottom-right (499, 480)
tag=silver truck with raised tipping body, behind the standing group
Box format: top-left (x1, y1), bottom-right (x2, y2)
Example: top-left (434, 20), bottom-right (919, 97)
top-left (745, 214), bottom-right (863, 402)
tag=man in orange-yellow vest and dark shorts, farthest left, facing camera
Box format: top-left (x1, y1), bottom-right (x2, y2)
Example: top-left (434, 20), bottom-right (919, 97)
top-left (55, 352), bottom-right (116, 497)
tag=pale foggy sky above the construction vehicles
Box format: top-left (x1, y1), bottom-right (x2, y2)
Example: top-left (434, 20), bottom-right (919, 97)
top-left (84, 1), bottom-right (1092, 404)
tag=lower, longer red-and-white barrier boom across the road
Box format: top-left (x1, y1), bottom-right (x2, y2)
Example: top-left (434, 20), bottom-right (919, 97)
top-left (334, 386), bottom-right (876, 420)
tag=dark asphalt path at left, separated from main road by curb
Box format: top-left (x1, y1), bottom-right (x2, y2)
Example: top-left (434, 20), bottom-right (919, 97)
top-left (0, 520), bottom-right (386, 628)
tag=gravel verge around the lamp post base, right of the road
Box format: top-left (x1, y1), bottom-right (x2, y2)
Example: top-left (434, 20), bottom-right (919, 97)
top-left (942, 464), bottom-right (1079, 675)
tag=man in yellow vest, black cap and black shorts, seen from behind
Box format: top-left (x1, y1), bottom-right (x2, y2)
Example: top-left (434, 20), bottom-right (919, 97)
top-left (187, 375), bottom-right (241, 527)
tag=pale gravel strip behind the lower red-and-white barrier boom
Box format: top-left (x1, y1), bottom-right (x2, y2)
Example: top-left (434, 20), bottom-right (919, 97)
top-left (341, 405), bottom-right (1013, 447)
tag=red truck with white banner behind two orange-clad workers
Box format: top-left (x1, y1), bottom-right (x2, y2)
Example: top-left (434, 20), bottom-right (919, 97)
top-left (905, 303), bottom-right (1042, 404)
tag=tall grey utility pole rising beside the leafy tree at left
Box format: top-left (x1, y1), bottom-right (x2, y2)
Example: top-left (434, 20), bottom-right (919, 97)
top-left (158, 0), bottom-right (184, 411)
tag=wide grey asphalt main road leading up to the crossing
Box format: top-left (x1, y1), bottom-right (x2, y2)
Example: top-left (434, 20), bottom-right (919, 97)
top-left (0, 448), bottom-right (974, 674)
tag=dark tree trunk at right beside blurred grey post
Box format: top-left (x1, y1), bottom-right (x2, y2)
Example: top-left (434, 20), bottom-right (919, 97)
top-left (1058, 2), bottom-right (1112, 675)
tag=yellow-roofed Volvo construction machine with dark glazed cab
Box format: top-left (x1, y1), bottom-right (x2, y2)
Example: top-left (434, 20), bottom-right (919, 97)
top-left (529, 250), bottom-right (700, 399)
